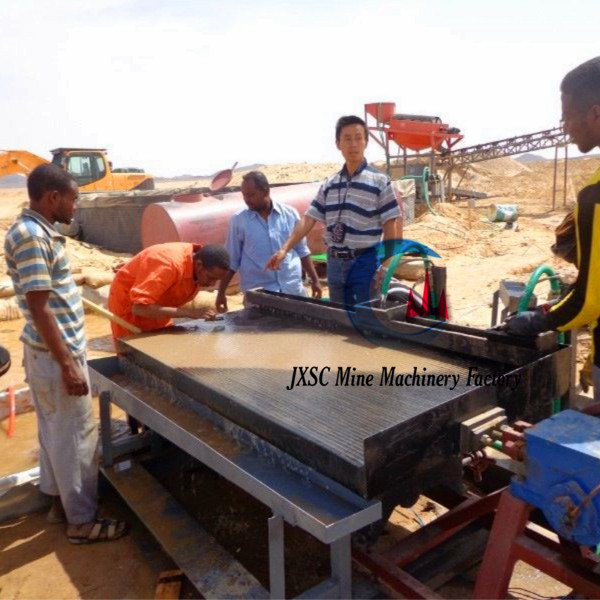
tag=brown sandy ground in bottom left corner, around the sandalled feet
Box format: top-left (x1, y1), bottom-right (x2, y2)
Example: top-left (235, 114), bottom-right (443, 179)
top-left (0, 486), bottom-right (175, 599)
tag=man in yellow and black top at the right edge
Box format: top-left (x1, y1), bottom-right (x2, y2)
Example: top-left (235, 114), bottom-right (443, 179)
top-left (505, 56), bottom-right (600, 402)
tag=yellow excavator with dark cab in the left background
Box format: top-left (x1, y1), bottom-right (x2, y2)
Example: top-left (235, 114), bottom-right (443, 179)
top-left (0, 148), bottom-right (154, 192)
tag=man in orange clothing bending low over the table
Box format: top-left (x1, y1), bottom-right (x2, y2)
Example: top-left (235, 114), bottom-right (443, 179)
top-left (108, 242), bottom-right (229, 340)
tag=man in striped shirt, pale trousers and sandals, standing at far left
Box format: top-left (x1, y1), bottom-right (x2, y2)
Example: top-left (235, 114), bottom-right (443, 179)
top-left (4, 164), bottom-right (127, 544)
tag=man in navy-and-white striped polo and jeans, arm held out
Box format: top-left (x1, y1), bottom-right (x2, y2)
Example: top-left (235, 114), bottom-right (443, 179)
top-left (268, 116), bottom-right (402, 305)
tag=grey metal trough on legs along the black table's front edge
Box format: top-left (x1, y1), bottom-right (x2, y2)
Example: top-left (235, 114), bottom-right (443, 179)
top-left (88, 357), bottom-right (381, 598)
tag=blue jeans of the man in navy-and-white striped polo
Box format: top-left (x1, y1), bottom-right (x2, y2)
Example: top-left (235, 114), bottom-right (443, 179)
top-left (327, 252), bottom-right (377, 306)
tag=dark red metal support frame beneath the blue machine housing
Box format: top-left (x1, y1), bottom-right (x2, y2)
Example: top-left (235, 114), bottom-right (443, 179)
top-left (352, 488), bottom-right (600, 598)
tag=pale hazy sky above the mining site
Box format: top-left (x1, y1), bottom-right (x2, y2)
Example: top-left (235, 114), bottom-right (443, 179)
top-left (0, 0), bottom-right (600, 176)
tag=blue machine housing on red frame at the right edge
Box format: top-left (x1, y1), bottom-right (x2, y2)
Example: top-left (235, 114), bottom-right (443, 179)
top-left (510, 410), bottom-right (600, 546)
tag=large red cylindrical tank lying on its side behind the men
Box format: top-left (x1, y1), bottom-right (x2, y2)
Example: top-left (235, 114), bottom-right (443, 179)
top-left (141, 183), bottom-right (326, 254)
